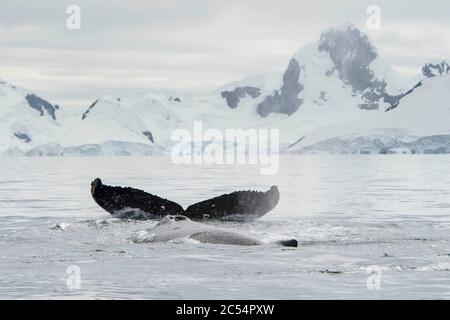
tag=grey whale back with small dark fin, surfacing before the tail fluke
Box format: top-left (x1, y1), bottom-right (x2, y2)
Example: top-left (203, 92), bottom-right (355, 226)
top-left (136, 215), bottom-right (298, 247)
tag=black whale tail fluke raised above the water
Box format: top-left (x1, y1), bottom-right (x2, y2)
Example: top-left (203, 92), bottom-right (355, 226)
top-left (91, 178), bottom-right (280, 220)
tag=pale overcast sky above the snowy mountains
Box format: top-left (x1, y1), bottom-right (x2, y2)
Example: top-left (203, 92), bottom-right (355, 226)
top-left (0, 0), bottom-right (450, 106)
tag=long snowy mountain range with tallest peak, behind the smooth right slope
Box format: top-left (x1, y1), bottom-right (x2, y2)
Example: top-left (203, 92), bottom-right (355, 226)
top-left (0, 23), bottom-right (450, 155)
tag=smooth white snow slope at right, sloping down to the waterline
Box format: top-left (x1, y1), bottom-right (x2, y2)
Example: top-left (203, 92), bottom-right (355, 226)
top-left (287, 74), bottom-right (450, 154)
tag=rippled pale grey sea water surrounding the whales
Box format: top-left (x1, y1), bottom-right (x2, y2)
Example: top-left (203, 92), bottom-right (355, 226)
top-left (0, 155), bottom-right (450, 299)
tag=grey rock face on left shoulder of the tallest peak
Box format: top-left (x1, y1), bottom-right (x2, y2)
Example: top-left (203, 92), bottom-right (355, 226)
top-left (257, 58), bottom-right (303, 117)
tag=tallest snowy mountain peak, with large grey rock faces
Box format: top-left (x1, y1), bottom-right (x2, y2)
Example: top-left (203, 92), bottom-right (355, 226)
top-left (250, 22), bottom-right (412, 117)
